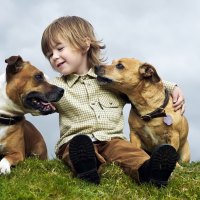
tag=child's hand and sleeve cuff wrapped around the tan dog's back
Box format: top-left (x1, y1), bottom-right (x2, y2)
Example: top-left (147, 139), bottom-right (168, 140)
top-left (163, 81), bottom-right (185, 114)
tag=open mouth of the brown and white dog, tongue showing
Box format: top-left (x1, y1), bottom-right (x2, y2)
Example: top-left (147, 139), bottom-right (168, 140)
top-left (24, 92), bottom-right (56, 115)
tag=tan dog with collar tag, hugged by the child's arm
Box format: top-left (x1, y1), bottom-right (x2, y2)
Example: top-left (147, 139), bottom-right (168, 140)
top-left (95, 58), bottom-right (190, 162)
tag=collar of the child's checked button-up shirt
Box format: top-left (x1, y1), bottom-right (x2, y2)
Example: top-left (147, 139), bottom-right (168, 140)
top-left (64, 68), bottom-right (97, 87)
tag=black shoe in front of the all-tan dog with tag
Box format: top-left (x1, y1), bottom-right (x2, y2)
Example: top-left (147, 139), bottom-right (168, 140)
top-left (139, 144), bottom-right (179, 187)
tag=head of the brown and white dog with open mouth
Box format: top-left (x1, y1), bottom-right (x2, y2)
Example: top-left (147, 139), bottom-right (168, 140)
top-left (5, 56), bottom-right (64, 115)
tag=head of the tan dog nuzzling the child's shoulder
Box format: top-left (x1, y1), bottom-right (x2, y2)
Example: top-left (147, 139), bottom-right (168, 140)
top-left (95, 58), bottom-right (160, 90)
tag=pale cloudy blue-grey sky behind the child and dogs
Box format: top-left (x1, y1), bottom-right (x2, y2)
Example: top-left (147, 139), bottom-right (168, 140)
top-left (0, 0), bottom-right (200, 161)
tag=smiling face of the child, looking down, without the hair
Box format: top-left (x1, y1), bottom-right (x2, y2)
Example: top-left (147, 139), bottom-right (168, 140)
top-left (47, 40), bottom-right (89, 75)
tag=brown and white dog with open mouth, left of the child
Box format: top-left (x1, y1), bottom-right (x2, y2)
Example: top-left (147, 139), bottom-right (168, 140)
top-left (0, 56), bottom-right (63, 174)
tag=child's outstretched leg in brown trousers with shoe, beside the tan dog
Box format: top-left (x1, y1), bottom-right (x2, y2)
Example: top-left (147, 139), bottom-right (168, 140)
top-left (98, 139), bottom-right (178, 186)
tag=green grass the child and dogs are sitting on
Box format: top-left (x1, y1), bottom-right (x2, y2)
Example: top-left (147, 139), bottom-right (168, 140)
top-left (0, 159), bottom-right (200, 200)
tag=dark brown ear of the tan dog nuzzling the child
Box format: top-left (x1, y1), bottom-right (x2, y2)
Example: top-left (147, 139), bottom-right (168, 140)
top-left (139, 63), bottom-right (160, 83)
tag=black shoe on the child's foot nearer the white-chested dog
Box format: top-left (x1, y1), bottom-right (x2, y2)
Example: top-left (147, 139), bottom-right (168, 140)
top-left (69, 135), bottom-right (100, 184)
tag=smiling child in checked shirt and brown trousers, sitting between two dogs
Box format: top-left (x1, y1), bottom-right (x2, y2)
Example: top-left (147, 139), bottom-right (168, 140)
top-left (41, 16), bottom-right (183, 187)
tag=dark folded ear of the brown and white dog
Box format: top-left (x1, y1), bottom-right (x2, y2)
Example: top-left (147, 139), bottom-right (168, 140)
top-left (5, 56), bottom-right (23, 81)
